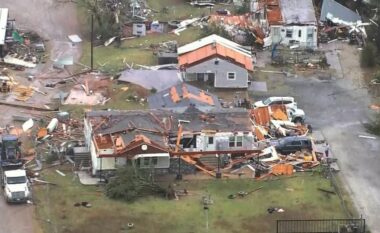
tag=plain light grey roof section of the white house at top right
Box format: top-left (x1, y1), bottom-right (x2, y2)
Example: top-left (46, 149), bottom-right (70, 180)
top-left (280, 0), bottom-right (317, 25)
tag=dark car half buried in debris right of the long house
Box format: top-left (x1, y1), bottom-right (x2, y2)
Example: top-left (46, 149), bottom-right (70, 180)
top-left (270, 136), bottom-right (313, 155)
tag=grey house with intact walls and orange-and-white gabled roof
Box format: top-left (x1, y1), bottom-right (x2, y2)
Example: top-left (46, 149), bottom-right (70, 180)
top-left (178, 35), bottom-right (253, 88)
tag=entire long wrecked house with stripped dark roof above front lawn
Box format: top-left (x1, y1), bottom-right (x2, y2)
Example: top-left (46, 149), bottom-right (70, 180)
top-left (84, 107), bottom-right (256, 176)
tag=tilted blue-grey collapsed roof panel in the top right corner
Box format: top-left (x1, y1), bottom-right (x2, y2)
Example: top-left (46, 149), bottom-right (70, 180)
top-left (319, 0), bottom-right (361, 24)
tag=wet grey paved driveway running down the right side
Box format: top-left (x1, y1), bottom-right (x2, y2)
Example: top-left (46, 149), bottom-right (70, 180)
top-left (255, 42), bottom-right (380, 233)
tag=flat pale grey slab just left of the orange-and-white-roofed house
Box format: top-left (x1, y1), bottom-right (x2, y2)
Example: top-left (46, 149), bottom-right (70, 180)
top-left (118, 70), bottom-right (182, 91)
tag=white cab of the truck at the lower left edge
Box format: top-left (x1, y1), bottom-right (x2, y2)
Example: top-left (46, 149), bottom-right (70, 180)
top-left (2, 169), bottom-right (31, 202)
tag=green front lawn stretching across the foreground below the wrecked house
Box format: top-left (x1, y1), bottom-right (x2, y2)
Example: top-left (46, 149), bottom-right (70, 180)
top-left (34, 167), bottom-right (351, 233)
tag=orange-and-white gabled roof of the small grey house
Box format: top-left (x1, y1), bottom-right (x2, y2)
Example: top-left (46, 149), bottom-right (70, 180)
top-left (178, 35), bottom-right (253, 71)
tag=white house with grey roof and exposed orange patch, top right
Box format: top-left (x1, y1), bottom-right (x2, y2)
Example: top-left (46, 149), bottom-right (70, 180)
top-left (268, 0), bottom-right (318, 49)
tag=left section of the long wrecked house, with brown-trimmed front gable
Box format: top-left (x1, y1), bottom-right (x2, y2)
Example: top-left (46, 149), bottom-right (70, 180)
top-left (84, 111), bottom-right (169, 176)
